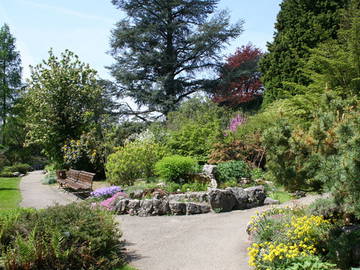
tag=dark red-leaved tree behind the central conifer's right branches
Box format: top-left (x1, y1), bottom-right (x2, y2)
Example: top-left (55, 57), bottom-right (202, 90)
top-left (213, 44), bottom-right (263, 107)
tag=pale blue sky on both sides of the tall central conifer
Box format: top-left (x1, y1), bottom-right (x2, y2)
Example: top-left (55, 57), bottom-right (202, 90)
top-left (0, 0), bottom-right (281, 79)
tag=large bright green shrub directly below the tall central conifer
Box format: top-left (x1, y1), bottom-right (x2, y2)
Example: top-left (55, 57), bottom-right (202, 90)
top-left (166, 98), bottom-right (229, 162)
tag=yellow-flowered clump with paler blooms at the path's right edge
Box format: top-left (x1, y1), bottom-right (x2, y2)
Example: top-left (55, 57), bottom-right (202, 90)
top-left (248, 209), bottom-right (333, 270)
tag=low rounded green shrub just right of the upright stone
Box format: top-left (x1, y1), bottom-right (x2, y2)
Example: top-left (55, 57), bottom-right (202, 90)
top-left (215, 160), bottom-right (250, 182)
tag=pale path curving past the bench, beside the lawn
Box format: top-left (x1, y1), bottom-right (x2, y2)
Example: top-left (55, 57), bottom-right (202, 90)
top-left (20, 171), bottom-right (79, 209)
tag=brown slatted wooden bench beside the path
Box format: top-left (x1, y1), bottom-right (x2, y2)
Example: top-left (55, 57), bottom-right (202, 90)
top-left (56, 169), bottom-right (95, 192)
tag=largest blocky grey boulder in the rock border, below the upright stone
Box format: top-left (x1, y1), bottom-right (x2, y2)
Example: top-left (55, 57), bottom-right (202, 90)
top-left (209, 189), bottom-right (237, 212)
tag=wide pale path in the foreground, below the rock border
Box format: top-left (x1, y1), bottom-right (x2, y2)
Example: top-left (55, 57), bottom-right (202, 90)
top-left (117, 196), bottom-right (319, 270)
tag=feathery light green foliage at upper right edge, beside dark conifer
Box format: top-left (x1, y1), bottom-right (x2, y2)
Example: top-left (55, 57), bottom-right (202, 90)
top-left (304, 1), bottom-right (360, 96)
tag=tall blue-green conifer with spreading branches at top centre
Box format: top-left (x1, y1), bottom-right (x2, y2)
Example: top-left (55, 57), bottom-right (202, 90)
top-left (110, 0), bottom-right (242, 115)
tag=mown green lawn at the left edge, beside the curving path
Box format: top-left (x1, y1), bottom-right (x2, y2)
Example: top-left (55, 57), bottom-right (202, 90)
top-left (0, 177), bottom-right (21, 209)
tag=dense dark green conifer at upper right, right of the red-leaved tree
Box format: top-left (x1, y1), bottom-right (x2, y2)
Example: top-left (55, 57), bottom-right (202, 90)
top-left (260, 0), bottom-right (348, 104)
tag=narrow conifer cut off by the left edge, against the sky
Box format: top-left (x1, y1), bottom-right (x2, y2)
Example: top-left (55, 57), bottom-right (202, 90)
top-left (0, 24), bottom-right (21, 144)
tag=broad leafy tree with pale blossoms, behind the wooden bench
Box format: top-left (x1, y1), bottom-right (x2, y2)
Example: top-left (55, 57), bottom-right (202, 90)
top-left (25, 50), bottom-right (106, 167)
